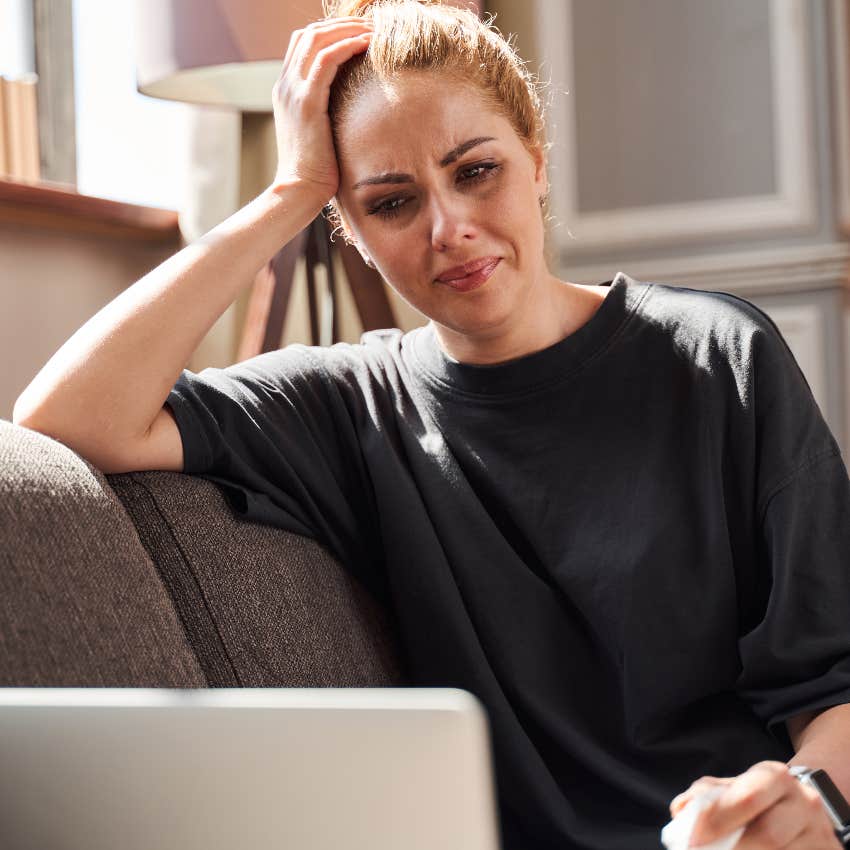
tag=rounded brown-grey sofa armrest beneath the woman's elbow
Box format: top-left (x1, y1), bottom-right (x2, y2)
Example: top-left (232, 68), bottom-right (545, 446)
top-left (0, 419), bottom-right (206, 687)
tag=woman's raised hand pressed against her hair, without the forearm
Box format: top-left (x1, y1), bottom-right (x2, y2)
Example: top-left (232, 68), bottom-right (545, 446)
top-left (272, 17), bottom-right (373, 204)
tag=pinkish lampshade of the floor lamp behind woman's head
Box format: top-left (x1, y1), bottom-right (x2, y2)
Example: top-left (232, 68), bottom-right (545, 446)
top-left (135, 0), bottom-right (481, 112)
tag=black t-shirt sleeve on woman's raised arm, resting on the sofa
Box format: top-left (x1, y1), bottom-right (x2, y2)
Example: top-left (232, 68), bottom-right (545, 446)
top-left (160, 345), bottom-right (384, 590)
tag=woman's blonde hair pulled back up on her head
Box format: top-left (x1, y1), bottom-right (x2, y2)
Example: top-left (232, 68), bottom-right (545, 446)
top-left (322, 0), bottom-right (549, 241)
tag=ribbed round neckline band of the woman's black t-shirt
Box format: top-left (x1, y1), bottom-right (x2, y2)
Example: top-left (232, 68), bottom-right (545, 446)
top-left (411, 272), bottom-right (641, 398)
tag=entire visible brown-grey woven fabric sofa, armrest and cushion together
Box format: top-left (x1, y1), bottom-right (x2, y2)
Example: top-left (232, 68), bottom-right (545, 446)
top-left (0, 419), bottom-right (406, 688)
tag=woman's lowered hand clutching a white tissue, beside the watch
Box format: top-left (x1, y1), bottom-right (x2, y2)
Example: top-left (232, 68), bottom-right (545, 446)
top-left (670, 761), bottom-right (841, 850)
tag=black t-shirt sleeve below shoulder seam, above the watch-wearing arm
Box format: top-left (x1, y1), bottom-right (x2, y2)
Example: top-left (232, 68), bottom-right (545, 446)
top-left (739, 452), bottom-right (850, 736)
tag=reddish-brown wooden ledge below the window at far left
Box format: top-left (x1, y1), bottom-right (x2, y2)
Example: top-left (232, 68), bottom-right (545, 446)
top-left (0, 178), bottom-right (181, 244)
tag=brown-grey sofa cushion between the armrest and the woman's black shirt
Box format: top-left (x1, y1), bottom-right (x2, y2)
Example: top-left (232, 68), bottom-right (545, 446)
top-left (107, 472), bottom-right (408, 687)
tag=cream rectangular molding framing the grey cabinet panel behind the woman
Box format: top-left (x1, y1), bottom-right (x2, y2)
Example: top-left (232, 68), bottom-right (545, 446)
top-left (535, 0), bottom-right (817, 257)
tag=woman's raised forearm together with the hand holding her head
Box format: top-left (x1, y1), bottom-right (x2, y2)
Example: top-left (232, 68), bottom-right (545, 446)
top-left (12, 18), bottom-right (372, 471)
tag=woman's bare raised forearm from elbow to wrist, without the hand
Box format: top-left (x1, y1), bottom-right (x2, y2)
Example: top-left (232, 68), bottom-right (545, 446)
top-left (12, 183), bottom-right (323, 469)
